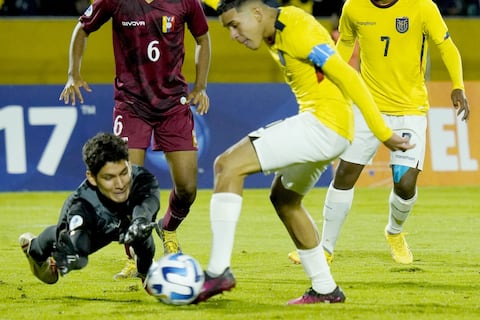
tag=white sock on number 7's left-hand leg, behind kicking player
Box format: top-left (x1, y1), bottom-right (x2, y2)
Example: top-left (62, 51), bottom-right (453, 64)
top-left (322, 183), bottom-right (354, 254)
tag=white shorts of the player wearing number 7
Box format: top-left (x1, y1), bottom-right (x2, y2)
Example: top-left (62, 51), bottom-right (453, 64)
top-left (340, 107), bottom-right (427, 170)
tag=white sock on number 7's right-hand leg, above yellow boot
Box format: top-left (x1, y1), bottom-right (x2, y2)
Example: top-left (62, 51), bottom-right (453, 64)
top-left (386, 189), bottom-right (417, 234)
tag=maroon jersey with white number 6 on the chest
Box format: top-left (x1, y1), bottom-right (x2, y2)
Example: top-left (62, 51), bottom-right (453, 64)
top-left (80, 0), bottom-right (208, 119)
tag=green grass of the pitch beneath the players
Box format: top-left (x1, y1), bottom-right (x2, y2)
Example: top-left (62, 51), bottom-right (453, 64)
top-left (0, 187), bottom-right (480, 320)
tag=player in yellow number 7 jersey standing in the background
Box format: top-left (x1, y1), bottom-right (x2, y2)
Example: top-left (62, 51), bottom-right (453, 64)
top-left (289, 0), bottom-right (470, 264)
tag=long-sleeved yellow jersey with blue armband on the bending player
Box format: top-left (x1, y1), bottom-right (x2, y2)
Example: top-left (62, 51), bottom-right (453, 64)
top-left (265, 6), bottom-right (392, 141)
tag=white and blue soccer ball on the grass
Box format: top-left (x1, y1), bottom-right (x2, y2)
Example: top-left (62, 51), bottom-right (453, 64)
top-left (146, 253), bottom-right (205, 305)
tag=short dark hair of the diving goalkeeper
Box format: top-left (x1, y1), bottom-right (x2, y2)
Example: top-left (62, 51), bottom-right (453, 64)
top-left (82, 132), bottom-right (128, 176)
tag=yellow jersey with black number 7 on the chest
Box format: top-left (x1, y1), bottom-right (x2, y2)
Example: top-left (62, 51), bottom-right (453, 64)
top-left (337, 0), bottom-right (449, 115)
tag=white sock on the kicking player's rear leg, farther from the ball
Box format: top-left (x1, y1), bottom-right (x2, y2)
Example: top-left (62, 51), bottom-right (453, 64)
top-left (298, 245), bottom-right (337, 294)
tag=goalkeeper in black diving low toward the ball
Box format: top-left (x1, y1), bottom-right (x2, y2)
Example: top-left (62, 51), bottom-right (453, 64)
top-left (19, 133), bottom-right (160, 284)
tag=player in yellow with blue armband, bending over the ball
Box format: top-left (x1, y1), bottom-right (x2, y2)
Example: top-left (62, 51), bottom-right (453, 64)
top-left (195, 0), bottom-right (413, 304)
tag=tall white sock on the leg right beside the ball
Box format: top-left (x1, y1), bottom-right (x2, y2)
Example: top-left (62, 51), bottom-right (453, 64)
top-left (207, 193), bottom-right (242, 276)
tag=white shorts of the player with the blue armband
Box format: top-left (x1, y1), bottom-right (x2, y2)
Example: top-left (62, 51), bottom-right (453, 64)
top-left (248, 112), bottom-right (349, 195)
